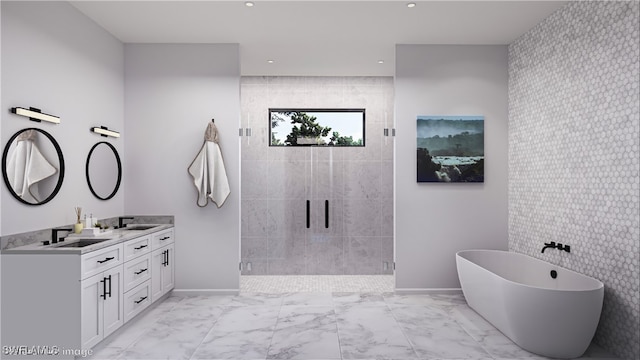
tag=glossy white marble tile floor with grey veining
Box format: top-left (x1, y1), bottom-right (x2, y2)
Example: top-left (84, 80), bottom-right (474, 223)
top-left (89, 292), bottom-right (614, 360)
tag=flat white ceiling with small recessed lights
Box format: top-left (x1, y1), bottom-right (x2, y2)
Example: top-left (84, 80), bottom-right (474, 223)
top-left (71, 0), bottom-right (566, 76)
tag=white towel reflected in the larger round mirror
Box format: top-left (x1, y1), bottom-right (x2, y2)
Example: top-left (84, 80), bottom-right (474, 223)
top-left (7, 130), bottom-right (58, 203)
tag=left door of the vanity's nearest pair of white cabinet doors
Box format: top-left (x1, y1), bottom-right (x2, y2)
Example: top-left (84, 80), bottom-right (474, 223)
top-left (80, 274), bottom-right (104, 349)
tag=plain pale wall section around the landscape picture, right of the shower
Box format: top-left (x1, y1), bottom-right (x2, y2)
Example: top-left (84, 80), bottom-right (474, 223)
top-left (395, 45), bottom-right (508, 290)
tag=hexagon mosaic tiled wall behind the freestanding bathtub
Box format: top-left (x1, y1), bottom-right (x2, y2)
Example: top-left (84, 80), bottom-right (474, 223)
top-left (509, 1), bottom-right (640, 359)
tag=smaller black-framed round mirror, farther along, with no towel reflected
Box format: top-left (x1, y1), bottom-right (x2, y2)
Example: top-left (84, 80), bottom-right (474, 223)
top-left (87, 141), bottom-right (122, 200)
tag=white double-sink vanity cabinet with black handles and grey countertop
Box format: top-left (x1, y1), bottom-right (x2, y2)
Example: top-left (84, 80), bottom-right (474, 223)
top-left (2, 224), bottom-right (174, 358)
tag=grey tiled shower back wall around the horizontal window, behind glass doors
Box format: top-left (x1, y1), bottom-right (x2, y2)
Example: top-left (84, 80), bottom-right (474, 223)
top-left (241, 77), bottom-right (394, 275)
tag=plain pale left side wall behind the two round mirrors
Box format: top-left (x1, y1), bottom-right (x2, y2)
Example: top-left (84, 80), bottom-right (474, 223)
top-left (0, 1), bottom-right (127, 235)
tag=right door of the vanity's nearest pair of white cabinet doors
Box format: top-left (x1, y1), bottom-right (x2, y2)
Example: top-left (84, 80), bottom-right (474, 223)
top-left (99, 266), bottom-right (124, 337)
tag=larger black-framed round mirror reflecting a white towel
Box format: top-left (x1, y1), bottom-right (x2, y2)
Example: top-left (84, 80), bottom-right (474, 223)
top-left (2, 128), bottom-right (64, 205)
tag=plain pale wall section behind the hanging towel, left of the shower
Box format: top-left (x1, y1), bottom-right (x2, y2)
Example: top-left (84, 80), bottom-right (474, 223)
top-left (124, 44), bottom-right (240, 290)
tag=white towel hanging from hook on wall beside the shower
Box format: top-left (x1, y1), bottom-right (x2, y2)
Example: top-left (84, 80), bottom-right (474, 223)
top-left (188, 122), bottom-right (231, 207)
